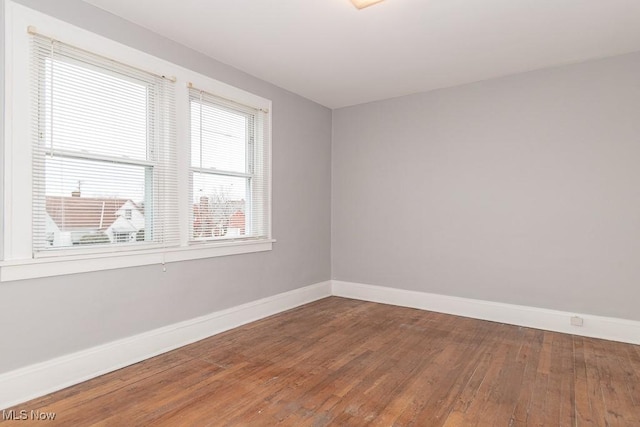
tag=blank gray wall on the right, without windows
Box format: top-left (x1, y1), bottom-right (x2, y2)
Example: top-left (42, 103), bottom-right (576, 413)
top-left (332, 53), bottom-right (640, 320)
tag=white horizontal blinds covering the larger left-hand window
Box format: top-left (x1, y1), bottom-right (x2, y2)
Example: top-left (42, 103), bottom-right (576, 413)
top-left (31, 35), bottom-right (179, 253)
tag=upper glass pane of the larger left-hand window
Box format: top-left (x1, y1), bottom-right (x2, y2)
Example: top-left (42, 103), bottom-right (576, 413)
top-left (42, 58), bottom-right (148, 160)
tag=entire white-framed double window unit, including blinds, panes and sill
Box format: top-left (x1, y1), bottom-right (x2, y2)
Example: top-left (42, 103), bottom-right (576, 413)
top-left (0, 5), bottom-right (273, 281)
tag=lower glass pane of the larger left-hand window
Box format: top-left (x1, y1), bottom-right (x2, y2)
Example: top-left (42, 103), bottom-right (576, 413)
top-left (45, 158), bottom-right (153, 248)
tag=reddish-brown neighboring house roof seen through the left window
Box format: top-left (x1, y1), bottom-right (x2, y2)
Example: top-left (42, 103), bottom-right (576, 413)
top-left (46, 196), bottom-right (138, 231)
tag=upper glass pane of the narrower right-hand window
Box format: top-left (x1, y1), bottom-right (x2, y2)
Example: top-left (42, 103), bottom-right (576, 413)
top-left (191, 100), bottom-right (249, 172)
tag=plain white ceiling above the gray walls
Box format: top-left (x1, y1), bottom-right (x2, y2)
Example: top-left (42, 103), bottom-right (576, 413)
top-left (85, 0), bottom-right (640, 108)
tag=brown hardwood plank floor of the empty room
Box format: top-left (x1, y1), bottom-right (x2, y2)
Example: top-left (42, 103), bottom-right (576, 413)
top-left (0, 297), bottom-right (640, 427)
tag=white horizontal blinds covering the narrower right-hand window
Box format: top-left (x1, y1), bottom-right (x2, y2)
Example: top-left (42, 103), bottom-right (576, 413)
top-left (189, 87), bottom-right (270, 241)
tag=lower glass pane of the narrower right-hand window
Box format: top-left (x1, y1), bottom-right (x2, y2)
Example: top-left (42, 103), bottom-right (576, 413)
top-left (192, 173), bottom-right (249, 239)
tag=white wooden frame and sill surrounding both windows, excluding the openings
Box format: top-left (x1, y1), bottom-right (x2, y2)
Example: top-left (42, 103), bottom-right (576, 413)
top-left (0, 0), bottom-right (275, 282)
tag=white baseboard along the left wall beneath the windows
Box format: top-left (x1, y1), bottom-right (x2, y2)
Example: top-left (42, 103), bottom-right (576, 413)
top-left (0, 281), bottom-right (331, 410)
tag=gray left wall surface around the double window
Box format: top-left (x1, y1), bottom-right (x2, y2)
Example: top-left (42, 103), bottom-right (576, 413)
top-left (0, 0), bottom-right (331, 373)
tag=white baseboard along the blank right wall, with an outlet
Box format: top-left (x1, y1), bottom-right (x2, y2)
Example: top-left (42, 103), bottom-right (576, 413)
top-left (331, 280), bottom-right (640, 344)
